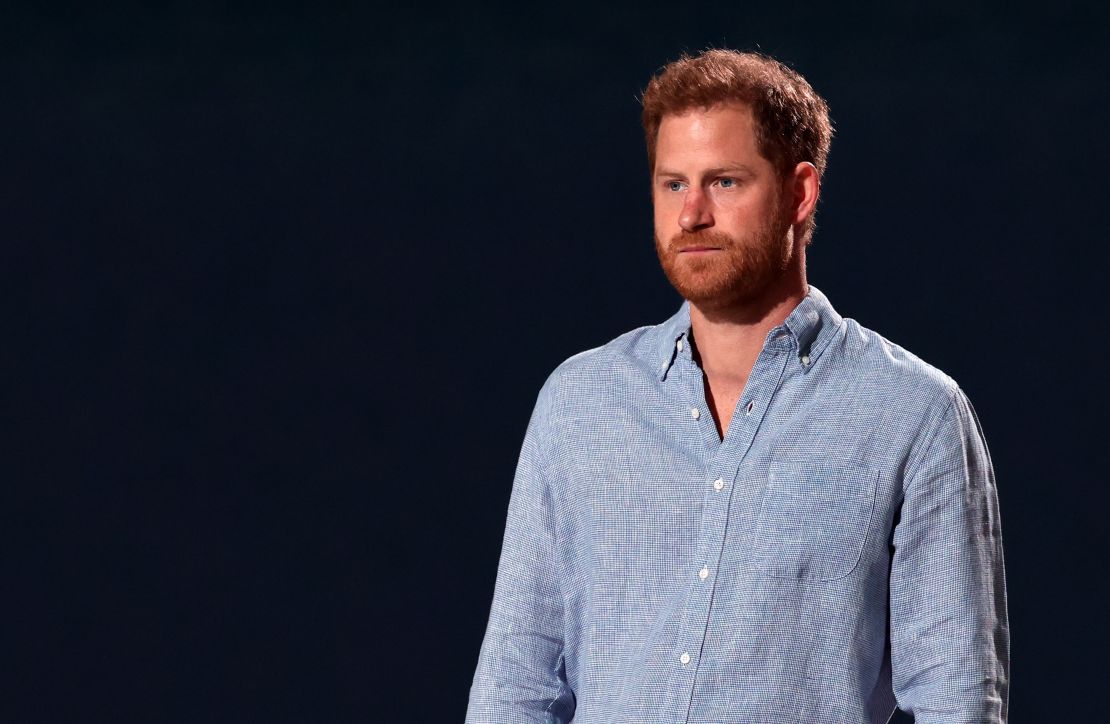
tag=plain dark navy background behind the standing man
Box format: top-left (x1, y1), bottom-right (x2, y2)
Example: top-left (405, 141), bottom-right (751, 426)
top-left (10, 2), bottom-right (1110, 722)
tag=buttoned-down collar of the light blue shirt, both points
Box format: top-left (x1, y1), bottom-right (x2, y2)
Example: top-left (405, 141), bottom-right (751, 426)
top-left (656, 284), bottom-right (844, 380)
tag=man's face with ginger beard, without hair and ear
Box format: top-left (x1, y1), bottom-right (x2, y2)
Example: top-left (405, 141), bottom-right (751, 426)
top-left (652, 104), bottom-right (794, 309)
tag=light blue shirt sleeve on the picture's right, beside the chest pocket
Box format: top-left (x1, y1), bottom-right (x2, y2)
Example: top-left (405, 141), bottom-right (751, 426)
top-left (890, 388), bottom-right (1010, 724)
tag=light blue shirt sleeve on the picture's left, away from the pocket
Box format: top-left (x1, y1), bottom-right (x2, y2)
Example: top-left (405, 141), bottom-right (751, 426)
top-left (466, 384), bottom-right (574, 724)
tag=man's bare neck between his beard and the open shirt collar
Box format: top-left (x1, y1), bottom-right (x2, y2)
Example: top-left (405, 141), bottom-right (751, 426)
top-left (690, 269), bottom-right (809, 379)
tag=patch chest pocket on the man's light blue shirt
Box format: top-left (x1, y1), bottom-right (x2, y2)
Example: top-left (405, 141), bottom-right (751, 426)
top-left (753, 462), bottom-right (878, 581)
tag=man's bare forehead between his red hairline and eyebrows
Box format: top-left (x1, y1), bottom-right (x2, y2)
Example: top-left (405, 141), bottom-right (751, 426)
top-left (655, 102), bottom-right (761, 164)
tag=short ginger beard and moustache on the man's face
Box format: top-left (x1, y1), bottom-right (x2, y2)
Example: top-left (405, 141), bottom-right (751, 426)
top-left (655, 189), bottom-right (794, 310)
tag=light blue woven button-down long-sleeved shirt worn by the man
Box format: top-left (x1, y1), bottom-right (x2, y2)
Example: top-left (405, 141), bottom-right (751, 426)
top-left (466, 285), bottom-right (1009, 724)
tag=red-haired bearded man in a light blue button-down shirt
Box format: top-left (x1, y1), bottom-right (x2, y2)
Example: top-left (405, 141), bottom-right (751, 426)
top-left (467, 50), bottom-right (1009, 724)
